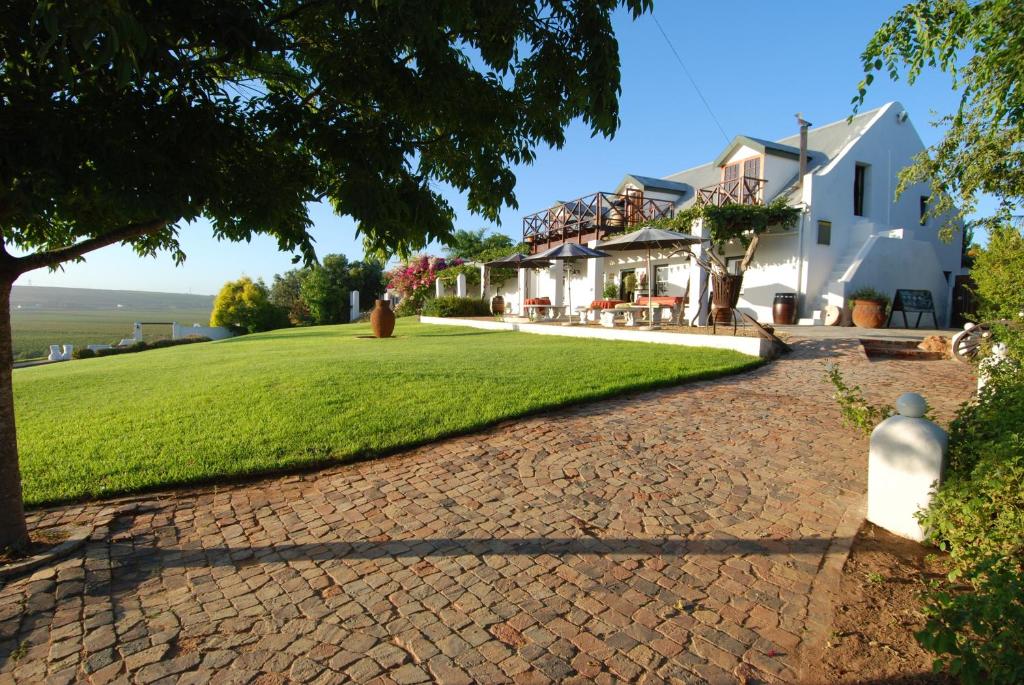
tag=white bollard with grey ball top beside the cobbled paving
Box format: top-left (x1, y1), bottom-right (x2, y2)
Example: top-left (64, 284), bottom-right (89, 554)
top-left (867, 392), bottom-right (948, 542)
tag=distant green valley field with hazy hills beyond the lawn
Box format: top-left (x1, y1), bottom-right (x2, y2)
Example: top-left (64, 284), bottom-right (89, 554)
top-left (10, 286), bottom-right (213, 360)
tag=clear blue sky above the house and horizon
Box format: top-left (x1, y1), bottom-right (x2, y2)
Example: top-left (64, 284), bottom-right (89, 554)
top-left (17, 0), bottom-right (974, 294)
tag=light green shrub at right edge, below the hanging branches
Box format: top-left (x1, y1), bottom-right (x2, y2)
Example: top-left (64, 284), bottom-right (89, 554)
top-left (971, 224), bottom-right (1024, 319)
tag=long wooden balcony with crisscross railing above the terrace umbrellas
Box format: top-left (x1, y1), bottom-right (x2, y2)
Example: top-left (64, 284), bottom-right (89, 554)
top-left (522, 192), bottom-right (676, 254)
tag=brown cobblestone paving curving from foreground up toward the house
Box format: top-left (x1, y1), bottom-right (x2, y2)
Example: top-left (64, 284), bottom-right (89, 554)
top-left (0, 341), bottom-right (973, 685)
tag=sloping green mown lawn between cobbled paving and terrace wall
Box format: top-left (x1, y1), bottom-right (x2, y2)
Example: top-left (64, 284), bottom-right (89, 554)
top-left (14, 319), bottom-right (759, 505)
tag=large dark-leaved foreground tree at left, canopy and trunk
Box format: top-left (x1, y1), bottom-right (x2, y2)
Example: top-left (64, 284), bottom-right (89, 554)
top-left (0, 0), bottom-right (650, 548)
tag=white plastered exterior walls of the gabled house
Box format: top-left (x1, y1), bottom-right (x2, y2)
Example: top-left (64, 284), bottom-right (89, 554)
top-left (530, 102), bottom-right (965, 326)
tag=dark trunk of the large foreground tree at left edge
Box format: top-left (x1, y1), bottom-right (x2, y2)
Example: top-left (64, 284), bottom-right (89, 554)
top-left (0, 276), bottom-right (29, 550)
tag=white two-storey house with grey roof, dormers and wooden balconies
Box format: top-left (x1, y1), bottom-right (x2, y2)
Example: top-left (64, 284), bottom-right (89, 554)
top-left (501, 102), bottom-right (967, 326)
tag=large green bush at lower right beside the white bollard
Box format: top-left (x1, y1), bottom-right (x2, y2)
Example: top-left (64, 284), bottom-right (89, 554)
top-left (918, 333), bottom-right (1024, 683)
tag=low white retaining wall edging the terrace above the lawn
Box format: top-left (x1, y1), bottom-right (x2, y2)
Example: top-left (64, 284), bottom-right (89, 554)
top-left (420, 316), bottom-right (771, 357)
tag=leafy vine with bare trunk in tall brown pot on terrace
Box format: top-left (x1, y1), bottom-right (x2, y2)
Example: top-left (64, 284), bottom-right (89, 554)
top-left (648, 198), bottom-right (800, 322)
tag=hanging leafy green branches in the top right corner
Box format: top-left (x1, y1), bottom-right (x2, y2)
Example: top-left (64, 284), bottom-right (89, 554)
top-left (853, 0), bottom-right (1024, 236)
